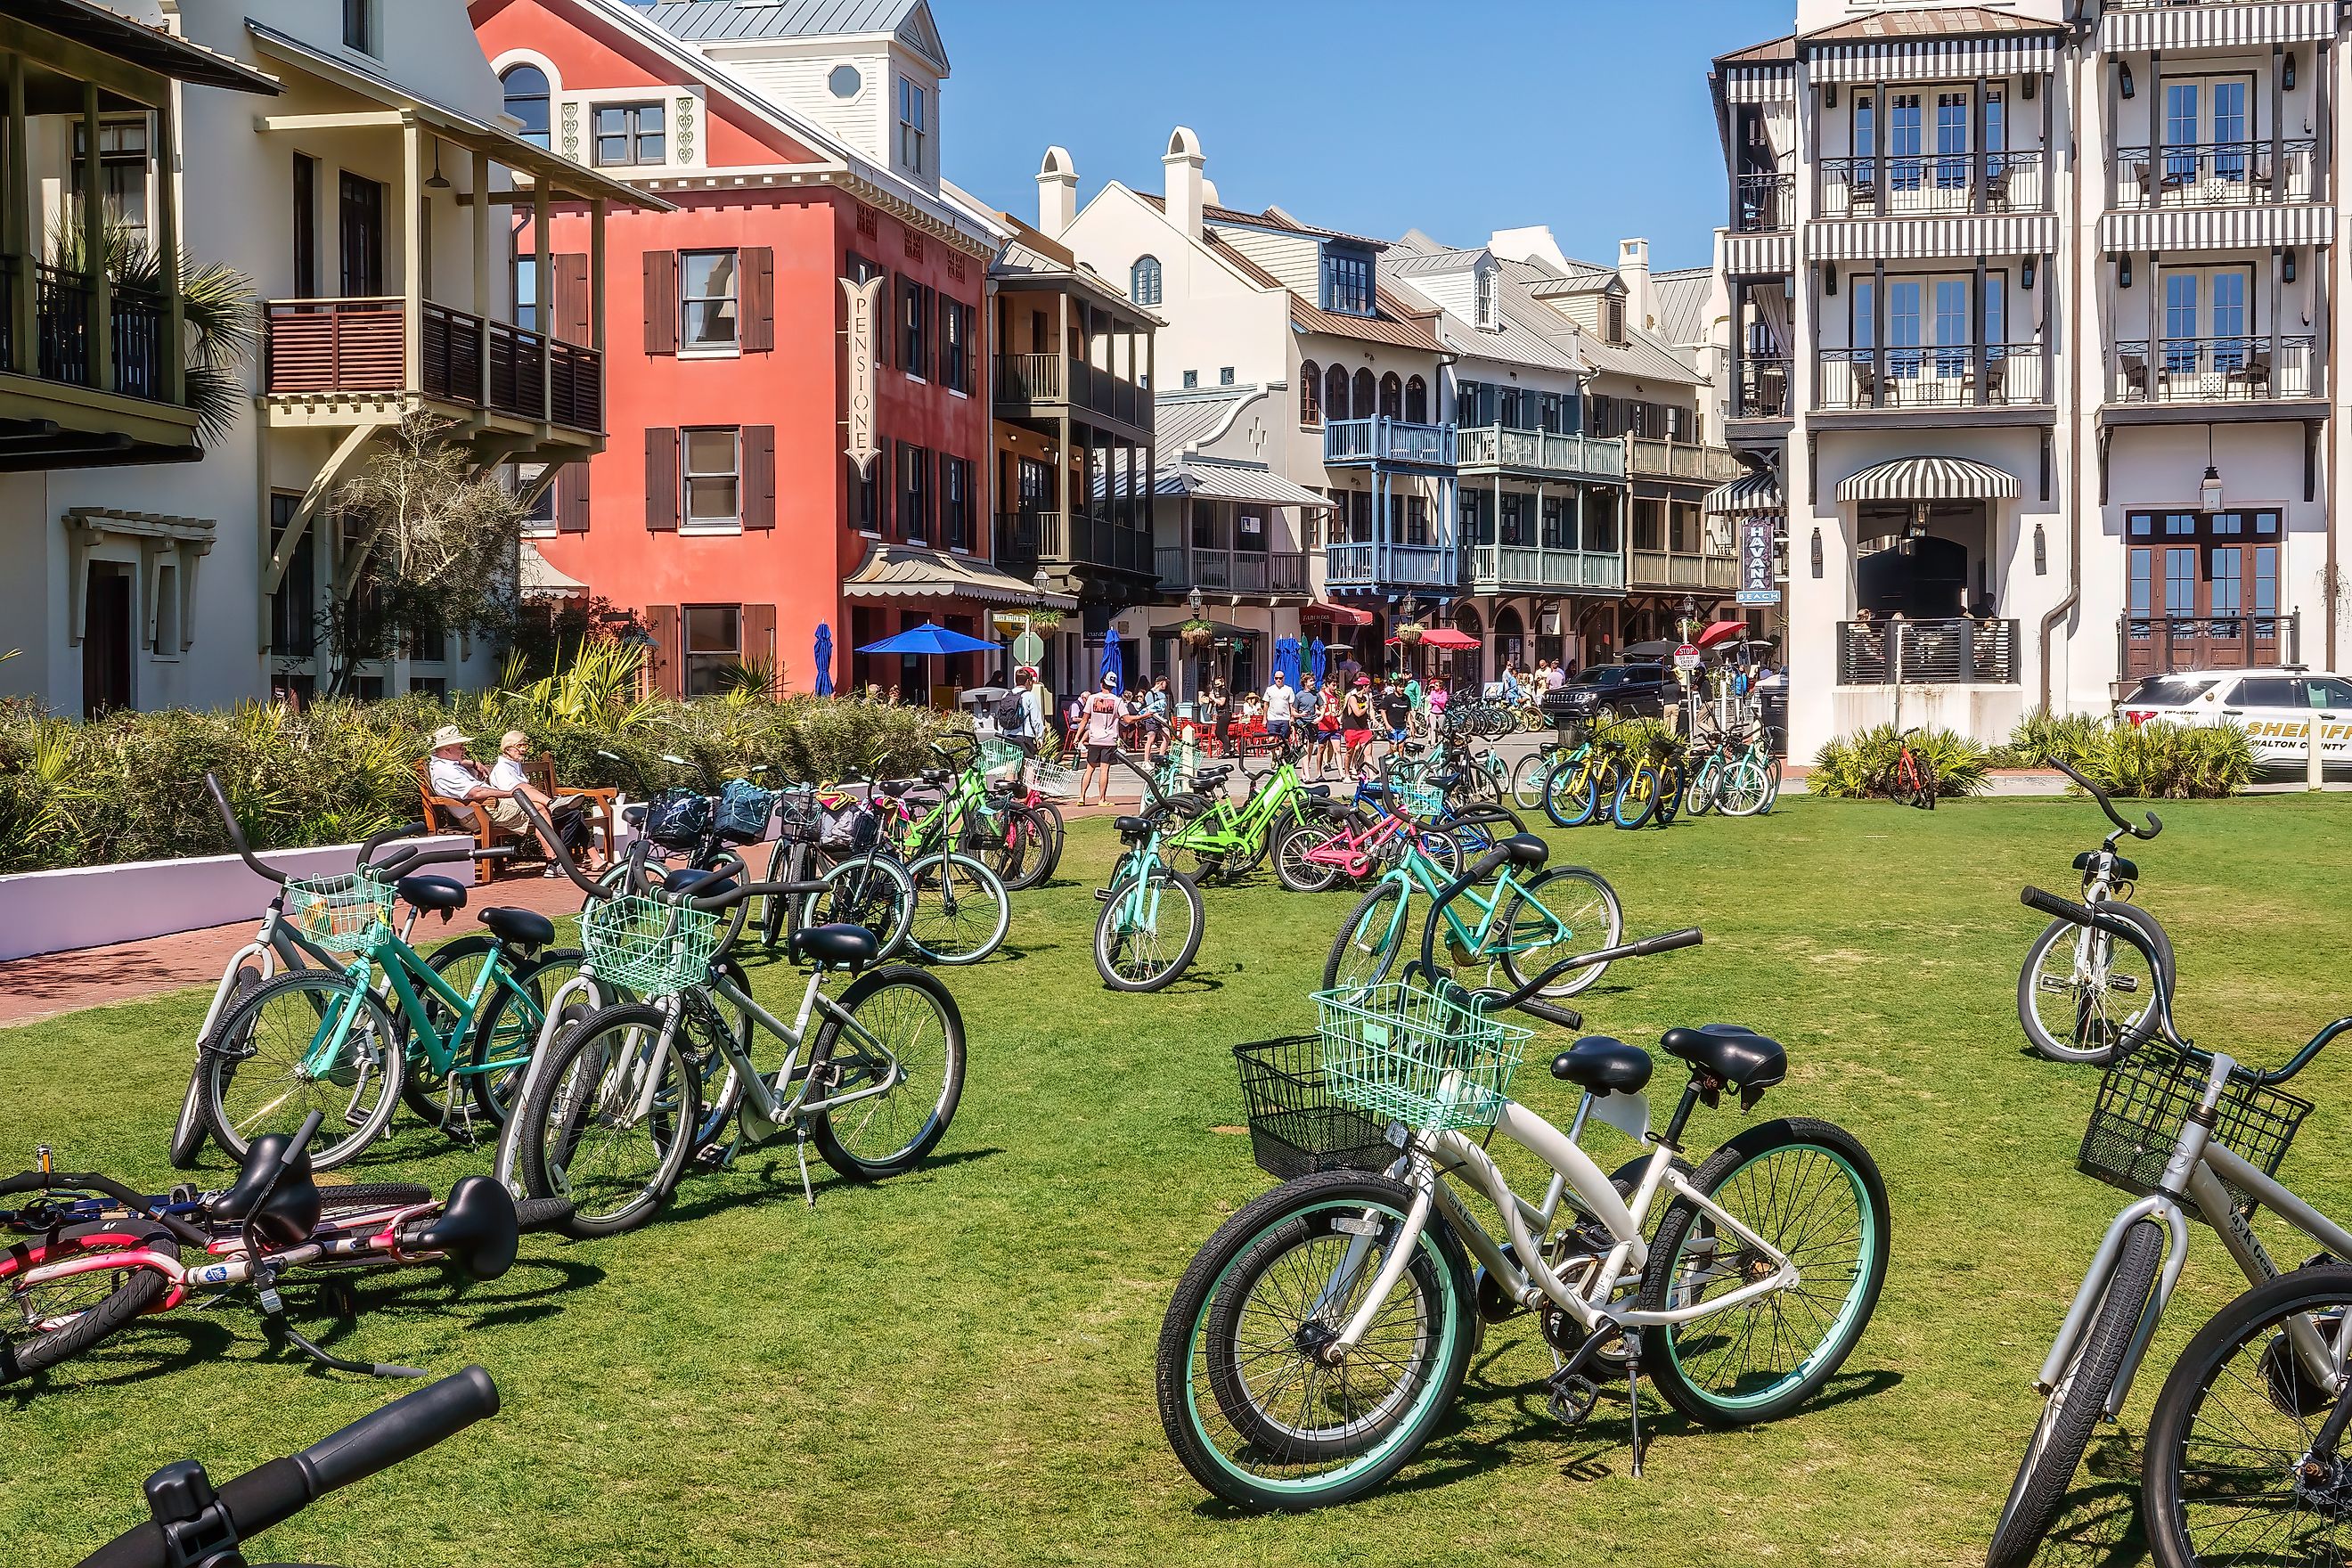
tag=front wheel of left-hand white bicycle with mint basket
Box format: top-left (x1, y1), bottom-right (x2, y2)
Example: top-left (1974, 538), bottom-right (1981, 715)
top-left (515, 1001), bottom-right (701, 1239)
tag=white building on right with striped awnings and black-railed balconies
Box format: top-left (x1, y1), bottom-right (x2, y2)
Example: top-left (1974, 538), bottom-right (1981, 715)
top-left (1712, 0), bottom-right (2348, 752)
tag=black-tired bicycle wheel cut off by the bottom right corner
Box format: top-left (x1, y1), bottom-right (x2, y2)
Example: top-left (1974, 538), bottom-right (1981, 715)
top-left (2140, 1265), bottom-right (2352, 1568)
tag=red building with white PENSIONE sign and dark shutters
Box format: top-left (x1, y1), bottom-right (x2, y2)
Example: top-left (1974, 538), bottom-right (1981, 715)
top-left (473, 0), bottom-right (1049, 696)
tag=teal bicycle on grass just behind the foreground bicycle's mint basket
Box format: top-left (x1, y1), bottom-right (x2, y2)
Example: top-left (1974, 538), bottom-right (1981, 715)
top-left (1324, 839), bottom-right (1625, 997)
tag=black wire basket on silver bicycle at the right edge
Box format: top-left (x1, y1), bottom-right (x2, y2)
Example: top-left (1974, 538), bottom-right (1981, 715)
top-left (2074, 1041), bottom-right (2312, 1213)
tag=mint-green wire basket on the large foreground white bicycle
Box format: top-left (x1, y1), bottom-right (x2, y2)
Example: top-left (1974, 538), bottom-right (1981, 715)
top-left (1315, 980), bottom-right (1533, 1133)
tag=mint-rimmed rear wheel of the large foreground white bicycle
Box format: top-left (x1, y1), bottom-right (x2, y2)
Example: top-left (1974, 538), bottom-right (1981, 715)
top-left (1642, 1116), bottom-right (1889, 1427)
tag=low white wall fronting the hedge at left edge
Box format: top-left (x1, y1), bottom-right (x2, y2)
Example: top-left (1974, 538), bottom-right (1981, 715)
top-left (0, 835), bottom-right (473, 960)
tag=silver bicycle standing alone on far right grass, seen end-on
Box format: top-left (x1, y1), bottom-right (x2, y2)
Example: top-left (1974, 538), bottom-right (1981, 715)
top-left (2018, 757), bottom-right (2173, 1067)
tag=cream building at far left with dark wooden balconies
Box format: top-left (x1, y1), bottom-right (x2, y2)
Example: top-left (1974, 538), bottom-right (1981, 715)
top-left (0, 0), bottom-right (631, 713)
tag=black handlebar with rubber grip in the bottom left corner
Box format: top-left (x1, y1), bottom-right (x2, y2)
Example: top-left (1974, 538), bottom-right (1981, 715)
top-left (80, 1366), bottom-right (499, 1568)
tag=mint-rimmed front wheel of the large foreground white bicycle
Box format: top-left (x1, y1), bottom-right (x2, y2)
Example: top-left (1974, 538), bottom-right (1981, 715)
top-left (1155, 1171), bottom-right (1477, 1512)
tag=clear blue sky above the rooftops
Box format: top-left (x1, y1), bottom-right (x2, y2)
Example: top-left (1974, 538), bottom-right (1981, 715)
top-left (931, 0), bottom-right (1797, 268)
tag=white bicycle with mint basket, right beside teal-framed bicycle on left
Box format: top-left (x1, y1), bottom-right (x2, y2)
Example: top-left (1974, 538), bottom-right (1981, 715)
top-left (513, 813), bottom-right (964, 1237)
